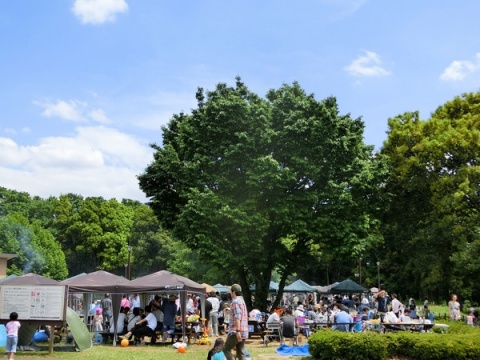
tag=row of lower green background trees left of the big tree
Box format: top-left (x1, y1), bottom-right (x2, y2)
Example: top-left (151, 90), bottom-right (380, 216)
top-left (0, 188), bottom-right (210, 280)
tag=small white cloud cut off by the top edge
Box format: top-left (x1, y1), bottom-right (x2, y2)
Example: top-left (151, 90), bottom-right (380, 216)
top-left (72, 0), bottom-right (128, 24)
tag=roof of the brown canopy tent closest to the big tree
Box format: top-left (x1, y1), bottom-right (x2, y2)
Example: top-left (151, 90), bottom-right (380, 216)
top-left (121, 270), bottom-right (205, 294)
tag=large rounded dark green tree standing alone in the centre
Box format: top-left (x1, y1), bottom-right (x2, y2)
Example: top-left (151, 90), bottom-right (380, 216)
top-left (139, 79), bottom-right (384, 308)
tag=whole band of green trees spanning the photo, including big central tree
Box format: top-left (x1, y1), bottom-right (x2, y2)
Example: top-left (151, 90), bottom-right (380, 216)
top-left (0, 79), bottom-right (480, 307)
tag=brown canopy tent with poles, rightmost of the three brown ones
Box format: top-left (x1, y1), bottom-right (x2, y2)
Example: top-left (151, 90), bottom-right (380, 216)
top-left (119, 270), bottom-right (206, 339)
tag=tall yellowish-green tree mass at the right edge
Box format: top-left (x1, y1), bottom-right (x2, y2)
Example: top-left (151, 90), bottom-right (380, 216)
top-left (382, 93), bottom-right (480, 300)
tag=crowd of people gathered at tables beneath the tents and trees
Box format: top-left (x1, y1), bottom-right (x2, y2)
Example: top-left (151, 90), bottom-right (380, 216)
top-left (62, 284), bottom-right (478, 360)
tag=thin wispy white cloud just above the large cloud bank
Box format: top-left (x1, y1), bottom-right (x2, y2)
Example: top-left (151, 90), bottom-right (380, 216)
top-left (33, 100), bottom-right (111, 124)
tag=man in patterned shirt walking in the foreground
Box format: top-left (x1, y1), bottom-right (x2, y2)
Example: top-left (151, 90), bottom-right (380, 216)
top-left (223, 284), bottom-right (248, 360)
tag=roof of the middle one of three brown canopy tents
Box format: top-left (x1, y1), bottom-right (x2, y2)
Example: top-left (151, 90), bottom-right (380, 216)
top-left (60, 270), bottom-right (130, 293)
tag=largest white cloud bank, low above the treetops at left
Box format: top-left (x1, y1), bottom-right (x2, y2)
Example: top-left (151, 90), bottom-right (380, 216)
top-left (0, 126), bottom-right (153, 201)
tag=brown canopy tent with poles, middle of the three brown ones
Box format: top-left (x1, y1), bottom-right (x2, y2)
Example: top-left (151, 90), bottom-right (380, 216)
top-left (60, 270), bottom-right (130, 345)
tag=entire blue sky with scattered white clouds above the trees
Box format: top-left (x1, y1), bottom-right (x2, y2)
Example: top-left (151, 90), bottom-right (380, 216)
top-left (0, 0), bottom-right (480, 201)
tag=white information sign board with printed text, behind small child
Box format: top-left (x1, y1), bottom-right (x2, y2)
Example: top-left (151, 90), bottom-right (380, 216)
top-left (0, 285), bottom-right (67, 321)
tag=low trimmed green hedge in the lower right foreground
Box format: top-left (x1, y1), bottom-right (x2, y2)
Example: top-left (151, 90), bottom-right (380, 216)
top-left (308, 326), bottom-right (480, 360)
